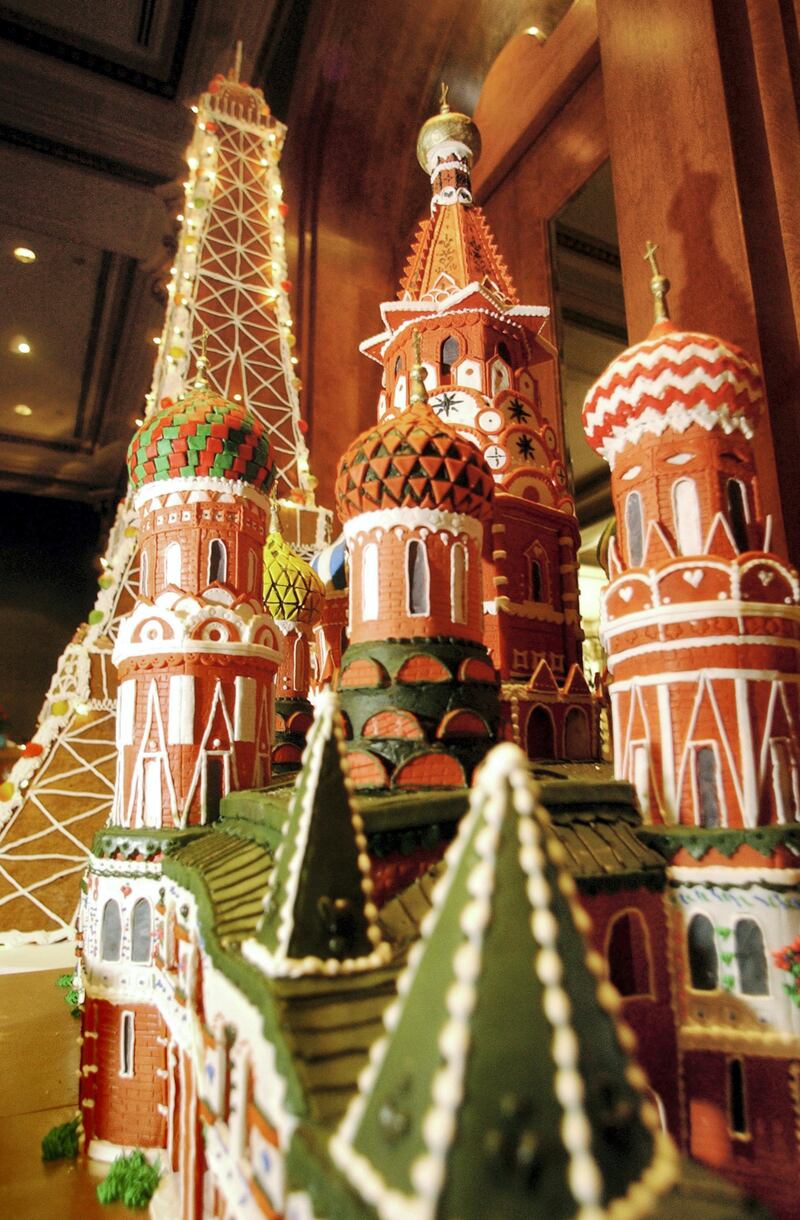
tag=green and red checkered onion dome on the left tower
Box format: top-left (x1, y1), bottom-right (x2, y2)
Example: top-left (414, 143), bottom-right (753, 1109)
top-left (128, 386), bottom-right (276, 492)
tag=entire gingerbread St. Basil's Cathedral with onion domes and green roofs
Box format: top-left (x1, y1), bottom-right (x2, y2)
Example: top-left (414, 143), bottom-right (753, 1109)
top-left (51, 64), bottom-right (800, 1220)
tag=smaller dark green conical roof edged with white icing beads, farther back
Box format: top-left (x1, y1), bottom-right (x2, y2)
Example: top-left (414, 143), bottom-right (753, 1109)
top-left (246, 691), bottom-right (389, 977)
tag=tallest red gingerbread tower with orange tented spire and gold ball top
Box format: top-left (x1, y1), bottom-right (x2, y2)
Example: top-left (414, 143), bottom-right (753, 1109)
top-left (361, 88), bottom-right (599, 759)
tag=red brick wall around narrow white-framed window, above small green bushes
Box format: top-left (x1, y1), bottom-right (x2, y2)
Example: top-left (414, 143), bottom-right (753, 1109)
top-left (80, 999), bottom-right (167, 1148)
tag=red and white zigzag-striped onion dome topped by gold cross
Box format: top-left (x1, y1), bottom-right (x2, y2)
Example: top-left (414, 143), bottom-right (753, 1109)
top-left (583, 244), bottom-right (763, 466)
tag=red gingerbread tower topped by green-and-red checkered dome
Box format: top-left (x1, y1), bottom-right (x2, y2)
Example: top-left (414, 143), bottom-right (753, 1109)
top-left (113, 360), bottom-right (283, 827)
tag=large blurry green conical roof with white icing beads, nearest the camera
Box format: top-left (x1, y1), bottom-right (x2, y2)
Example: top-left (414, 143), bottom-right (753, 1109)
top-left (330, 744), bottom-right (677, 1220)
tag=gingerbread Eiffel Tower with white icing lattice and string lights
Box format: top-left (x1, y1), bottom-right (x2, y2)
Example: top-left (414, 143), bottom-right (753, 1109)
top-left (0, 57), bottom-right (330, 946)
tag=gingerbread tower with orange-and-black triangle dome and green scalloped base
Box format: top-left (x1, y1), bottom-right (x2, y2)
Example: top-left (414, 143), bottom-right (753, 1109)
top-left (337, 334), bottom-right (498, 788)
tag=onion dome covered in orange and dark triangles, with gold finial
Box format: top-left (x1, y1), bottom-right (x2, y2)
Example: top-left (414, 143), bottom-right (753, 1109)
top-left (335, 336), bottom-right (494, 521)
